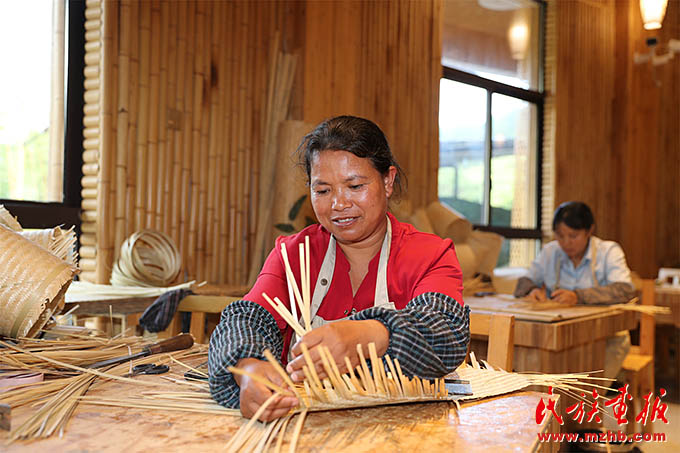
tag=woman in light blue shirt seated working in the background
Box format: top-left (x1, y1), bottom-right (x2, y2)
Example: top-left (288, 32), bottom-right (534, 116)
top-left (515, 201), bottom-right (635, 305)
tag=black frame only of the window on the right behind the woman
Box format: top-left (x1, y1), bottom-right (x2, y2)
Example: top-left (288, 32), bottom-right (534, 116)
top-left (442, 1), bottom-right (546, 244)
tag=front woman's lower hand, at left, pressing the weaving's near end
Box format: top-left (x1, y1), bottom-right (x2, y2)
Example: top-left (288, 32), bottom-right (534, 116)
top-left (234, 358), bottom-right (298, 422)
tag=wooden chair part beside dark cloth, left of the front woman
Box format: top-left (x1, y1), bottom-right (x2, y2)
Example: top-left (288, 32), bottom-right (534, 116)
top-left (158, 295), bottom-right (243, 343)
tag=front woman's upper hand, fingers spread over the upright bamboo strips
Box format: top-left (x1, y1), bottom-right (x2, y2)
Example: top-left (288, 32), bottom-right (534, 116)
top-left (286, 319), bottom-right (390, 382)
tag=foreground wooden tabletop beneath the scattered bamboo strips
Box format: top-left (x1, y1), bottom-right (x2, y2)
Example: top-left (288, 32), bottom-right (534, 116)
top-left (0, 360), bottom-right (563, 453)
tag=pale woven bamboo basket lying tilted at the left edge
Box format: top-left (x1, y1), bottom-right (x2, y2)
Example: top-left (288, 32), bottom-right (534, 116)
top-left (0, 223), bottom-right (78, 338)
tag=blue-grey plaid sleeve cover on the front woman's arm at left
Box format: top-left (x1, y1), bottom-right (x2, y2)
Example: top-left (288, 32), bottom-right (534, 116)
top-left (208, 300), bottom-right (283, 408)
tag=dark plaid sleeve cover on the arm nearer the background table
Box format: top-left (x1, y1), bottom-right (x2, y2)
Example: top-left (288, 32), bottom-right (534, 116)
top-left (351, 292), bottom-right (470, 379)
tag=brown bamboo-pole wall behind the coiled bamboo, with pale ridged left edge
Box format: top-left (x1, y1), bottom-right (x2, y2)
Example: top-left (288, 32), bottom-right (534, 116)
top-left (82, 0), bottom-right (294, 283)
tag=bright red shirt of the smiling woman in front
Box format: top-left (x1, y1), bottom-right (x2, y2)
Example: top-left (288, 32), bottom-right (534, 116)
top-left (244, 213), bottom-right (463, 332)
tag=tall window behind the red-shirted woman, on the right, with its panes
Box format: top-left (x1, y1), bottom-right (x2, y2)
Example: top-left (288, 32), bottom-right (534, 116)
top-left (438, 0), bottom-right (544, 266)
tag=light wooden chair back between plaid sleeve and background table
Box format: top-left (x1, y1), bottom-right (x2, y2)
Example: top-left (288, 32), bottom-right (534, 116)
top-left (470, 313), bottom-right (515, 371)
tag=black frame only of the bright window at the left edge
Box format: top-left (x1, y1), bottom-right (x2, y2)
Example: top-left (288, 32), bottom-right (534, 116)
top-left (0, 0), bottom-right (86, 230)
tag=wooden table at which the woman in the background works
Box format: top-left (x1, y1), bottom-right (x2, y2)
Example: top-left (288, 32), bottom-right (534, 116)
top-left (465, 295), bottom-right (637, 373)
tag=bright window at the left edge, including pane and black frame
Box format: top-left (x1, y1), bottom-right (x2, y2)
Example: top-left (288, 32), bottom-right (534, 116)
top-left (0, 0), bottom-right (85, 228)
